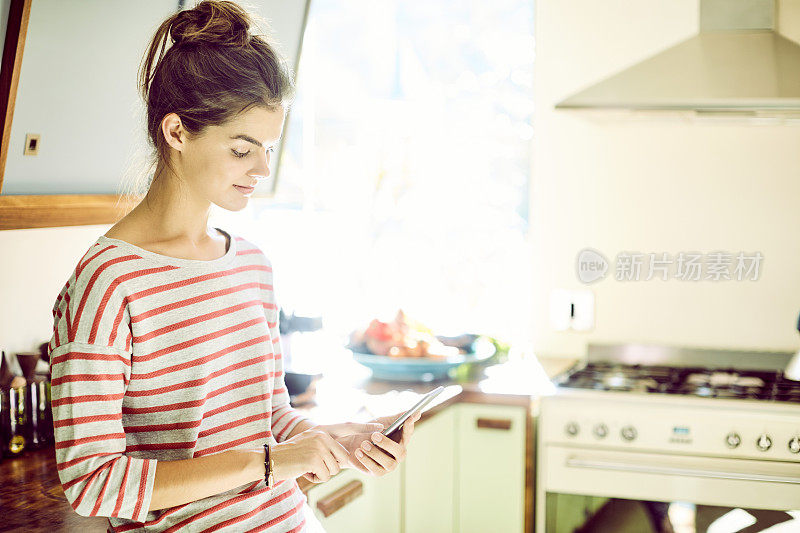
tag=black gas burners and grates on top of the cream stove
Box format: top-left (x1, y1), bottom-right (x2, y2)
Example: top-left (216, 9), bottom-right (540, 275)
top-left (559, 362), bottom-right (800, 402)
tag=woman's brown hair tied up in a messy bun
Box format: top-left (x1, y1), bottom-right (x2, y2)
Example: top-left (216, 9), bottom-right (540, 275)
top-left (126, 0), bottom-right (295, 197)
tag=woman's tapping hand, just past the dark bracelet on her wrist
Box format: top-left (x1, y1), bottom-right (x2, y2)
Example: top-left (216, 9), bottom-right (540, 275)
top-left (270, 428), bottom-right (349, 483)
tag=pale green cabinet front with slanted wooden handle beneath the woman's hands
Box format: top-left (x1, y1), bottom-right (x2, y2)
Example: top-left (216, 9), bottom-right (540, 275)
top-left (306, 460), bottom-right (404, 533)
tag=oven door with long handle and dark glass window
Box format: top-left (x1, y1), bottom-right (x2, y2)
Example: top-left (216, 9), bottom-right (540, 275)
top-left (537, 445), bottom-right (800, 533)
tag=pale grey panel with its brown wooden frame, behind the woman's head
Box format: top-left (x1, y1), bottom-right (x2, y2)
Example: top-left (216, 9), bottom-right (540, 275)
top-left (0, 0), bottom-right (311, 230)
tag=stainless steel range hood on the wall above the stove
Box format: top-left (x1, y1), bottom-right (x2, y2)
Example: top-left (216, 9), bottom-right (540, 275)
top-left (556, 0), bottom-right (800, 116)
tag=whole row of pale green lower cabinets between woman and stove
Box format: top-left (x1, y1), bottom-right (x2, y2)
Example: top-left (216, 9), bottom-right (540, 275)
top-left (307, 403), bottom-right (527, 533)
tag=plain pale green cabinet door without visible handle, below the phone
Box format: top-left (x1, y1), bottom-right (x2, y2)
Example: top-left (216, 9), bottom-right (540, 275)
top-left (403, 405), bottom-right (458, 533)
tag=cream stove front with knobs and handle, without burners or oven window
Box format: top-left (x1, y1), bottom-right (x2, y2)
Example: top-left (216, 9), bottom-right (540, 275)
top-left (536, 388), bottom-right (800, 533)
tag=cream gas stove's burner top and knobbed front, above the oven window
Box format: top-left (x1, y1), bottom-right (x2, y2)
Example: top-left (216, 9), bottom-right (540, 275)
top-left (536, 345), bottom-right (800, 532)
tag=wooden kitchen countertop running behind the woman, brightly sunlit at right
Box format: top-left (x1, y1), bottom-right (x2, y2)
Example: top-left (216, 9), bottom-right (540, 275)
top-left (0, 352), bottom-right (576, 533)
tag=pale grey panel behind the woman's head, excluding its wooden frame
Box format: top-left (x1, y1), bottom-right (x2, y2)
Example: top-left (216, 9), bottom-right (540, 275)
top-left (0, 0), bottom-right (306, 194)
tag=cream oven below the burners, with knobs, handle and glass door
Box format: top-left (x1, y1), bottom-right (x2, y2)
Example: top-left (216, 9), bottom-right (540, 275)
top-left (536, 344), bottom-right (800, 533)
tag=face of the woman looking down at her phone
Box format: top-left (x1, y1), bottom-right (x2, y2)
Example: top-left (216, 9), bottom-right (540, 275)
top-left (171, 106), bottom-right (286, 211)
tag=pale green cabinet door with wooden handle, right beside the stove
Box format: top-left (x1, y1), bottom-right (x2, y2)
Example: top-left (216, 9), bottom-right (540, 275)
top-left (455, 403), bottom-right (527, 533)
